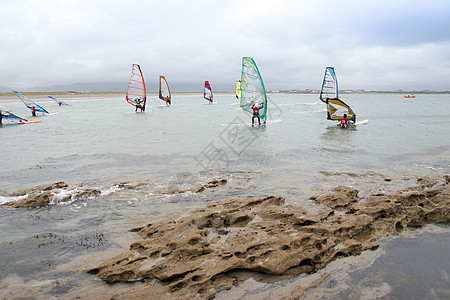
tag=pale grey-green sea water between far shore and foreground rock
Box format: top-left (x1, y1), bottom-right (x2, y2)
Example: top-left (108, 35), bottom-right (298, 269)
top-left (0, 93), bottom-right (450, 298)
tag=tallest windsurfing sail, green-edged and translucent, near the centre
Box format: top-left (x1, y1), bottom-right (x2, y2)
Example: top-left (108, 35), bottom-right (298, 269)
top-left (240, 57), bottom-right (267, 122)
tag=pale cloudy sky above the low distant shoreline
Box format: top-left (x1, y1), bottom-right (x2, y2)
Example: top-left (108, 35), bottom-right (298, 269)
top-left (0, 0), bottom-right (450, 91)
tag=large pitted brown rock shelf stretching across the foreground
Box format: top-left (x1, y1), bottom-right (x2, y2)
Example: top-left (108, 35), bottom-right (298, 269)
top-left (88, 180), bottom-right (450, 299)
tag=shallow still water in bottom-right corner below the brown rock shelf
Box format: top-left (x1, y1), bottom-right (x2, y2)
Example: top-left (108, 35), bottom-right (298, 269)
top-left (216, 225), bottom-right (450, 299)
